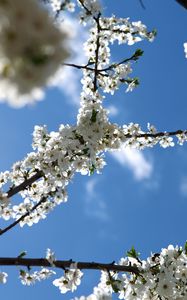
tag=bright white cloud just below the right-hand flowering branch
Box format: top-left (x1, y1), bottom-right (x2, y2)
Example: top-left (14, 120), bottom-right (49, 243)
top-left (111, 147), bottom-right (153, 181)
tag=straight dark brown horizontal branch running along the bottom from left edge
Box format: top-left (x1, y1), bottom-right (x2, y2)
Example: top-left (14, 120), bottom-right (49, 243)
top-left (0, 257), bottom-right (140, 274)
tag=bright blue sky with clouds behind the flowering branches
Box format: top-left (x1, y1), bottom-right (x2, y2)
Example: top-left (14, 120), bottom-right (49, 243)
top-left (0, 0), bottom-right (187, 300)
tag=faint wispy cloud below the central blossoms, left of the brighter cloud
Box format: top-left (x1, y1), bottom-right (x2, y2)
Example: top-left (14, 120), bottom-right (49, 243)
top-left (84, 178), bottom-right (109, 222)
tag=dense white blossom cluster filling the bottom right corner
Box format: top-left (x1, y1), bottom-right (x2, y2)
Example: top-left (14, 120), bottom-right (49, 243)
top-left (76, 245), bottom-right (187, 300)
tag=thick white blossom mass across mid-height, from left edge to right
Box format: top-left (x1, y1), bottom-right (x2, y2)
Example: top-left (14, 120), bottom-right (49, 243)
top-left (0, 109), bottom-right (186, 226)
